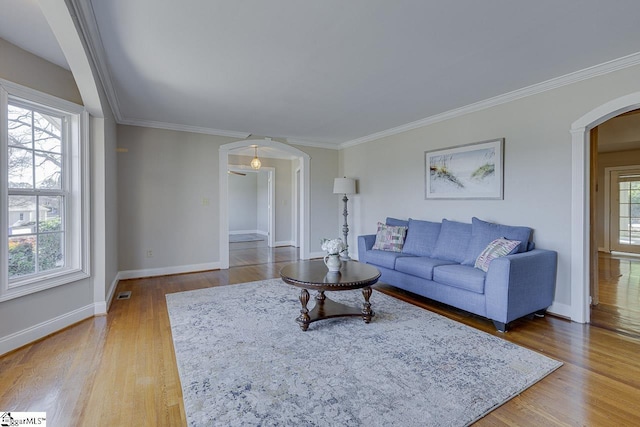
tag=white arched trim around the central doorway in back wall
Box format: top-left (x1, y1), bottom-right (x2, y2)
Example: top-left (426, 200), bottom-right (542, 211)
top-left (218, 138), bottom-right (311, 270)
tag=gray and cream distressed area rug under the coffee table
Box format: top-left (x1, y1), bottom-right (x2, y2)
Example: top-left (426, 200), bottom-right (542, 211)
top-left (167, 279), bottom-right (562, 426)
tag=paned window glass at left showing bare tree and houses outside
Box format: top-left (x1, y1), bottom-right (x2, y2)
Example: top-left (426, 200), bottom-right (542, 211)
top-left (8, 103), bottom-right (67, 279)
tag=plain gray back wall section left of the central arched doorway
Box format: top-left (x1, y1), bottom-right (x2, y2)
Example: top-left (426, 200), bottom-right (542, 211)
top-left (118, 125), bottom-right (232, 271)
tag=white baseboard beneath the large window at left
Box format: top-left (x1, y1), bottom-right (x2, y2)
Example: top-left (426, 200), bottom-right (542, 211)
top-left (0, 304), bottom-right (96, 355)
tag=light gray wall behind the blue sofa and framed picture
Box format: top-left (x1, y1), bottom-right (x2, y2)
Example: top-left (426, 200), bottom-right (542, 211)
top-left (341, 61), bottom-right (640, 312)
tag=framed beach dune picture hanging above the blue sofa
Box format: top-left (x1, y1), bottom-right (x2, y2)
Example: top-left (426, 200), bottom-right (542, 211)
top-left (424, 138), bottom-right (504, 200)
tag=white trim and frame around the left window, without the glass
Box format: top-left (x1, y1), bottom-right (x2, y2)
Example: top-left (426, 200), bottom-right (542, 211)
top-left (0, 79), bottom-right (91, 302)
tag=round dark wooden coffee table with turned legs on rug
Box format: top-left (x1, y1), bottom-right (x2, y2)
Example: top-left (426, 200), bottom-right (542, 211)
top-left (280, 260), bottom-right (380, 331)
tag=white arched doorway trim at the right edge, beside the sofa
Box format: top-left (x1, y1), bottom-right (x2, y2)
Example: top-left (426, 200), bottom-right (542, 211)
top-left (570, 92), bottom-right (640, 323)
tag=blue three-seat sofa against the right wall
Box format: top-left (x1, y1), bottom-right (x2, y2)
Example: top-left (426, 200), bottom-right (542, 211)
top-left (358, 217), bottom-right (558, 332)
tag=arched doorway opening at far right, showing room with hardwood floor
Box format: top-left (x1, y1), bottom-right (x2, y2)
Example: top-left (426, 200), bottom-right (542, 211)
top-left (589, 111), bottom-right (640, 337)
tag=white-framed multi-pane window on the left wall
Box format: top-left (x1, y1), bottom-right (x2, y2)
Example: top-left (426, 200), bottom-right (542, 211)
top-left (0, 80), bottom-right (89, 301)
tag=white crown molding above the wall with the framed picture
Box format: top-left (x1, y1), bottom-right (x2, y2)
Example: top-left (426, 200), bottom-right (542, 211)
top-left (340, 52), bottom-right (640, 148)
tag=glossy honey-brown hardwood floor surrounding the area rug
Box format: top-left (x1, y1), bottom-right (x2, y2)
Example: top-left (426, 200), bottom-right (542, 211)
top-left (0, 248), bottom-right (640, 426)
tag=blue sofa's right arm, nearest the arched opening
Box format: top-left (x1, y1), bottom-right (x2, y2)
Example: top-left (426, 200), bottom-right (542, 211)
top-left (484, 249), bottom-right (558, 324)
